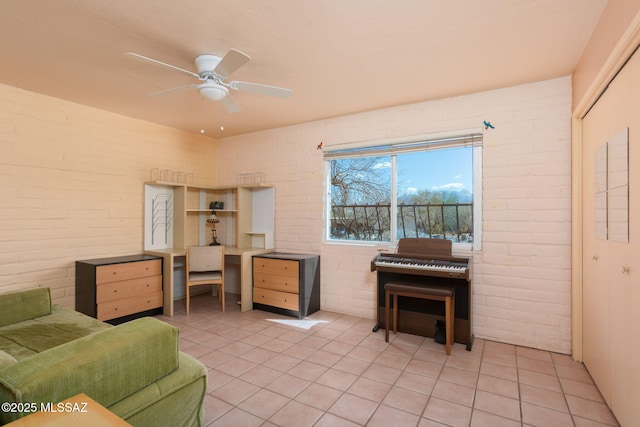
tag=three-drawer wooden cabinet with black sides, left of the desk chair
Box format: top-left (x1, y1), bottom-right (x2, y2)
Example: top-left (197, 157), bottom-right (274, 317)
top-left (76, 255), bottom-right (163, 323)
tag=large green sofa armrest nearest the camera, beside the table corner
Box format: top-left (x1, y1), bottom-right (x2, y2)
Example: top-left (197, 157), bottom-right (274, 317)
top-left (0, 317), bottom-right (179, 422)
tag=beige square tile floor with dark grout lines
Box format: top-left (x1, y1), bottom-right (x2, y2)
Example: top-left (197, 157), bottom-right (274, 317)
top-left (159, 295), bottom-right (618, 427)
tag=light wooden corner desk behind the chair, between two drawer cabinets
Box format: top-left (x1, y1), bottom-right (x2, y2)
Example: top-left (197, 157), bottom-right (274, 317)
top-left (144, 246), bottom-right (274, 316)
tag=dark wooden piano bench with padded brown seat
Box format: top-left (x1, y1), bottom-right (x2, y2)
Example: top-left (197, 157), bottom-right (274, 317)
top-left (384, 282), bottom-right (456, 354)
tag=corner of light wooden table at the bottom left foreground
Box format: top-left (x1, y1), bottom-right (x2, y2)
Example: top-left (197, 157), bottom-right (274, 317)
top-left (7, 393), bottom-right (131, 427)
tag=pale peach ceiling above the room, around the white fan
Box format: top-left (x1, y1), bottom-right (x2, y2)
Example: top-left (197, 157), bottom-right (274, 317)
top-left (0, 0), bottom-right (606, 138)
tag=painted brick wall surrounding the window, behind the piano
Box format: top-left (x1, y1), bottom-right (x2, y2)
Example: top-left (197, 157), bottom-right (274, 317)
top-left (218, 77), bottom-right (571, 353)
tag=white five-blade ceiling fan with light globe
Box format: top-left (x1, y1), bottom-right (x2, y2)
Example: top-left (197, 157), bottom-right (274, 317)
top-left (126, 49), bottom-right (291, 113)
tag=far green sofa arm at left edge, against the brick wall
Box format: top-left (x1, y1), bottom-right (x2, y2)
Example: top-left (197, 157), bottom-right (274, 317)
top-left (0, 288), bottom-right (51, 327)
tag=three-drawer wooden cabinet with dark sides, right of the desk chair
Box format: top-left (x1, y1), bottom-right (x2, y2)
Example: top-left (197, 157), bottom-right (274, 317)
top-left (253, 252), bottom-right (320, 319)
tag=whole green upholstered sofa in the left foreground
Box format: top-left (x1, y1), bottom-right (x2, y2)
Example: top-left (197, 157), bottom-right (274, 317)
top-left (0, 288), bottom-right (207, 427)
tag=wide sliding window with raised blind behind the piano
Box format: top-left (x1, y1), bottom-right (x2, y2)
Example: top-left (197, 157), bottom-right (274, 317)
top-left (325, 134), bottom-right (482, 249)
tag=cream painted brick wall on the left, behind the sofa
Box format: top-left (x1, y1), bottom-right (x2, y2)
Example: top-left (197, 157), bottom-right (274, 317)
top-left (0, 85), bottom-right (215, 307)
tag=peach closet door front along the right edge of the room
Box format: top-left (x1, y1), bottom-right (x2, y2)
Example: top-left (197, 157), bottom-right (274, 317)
top-left (583, 48), bottom-right (640, 426)
